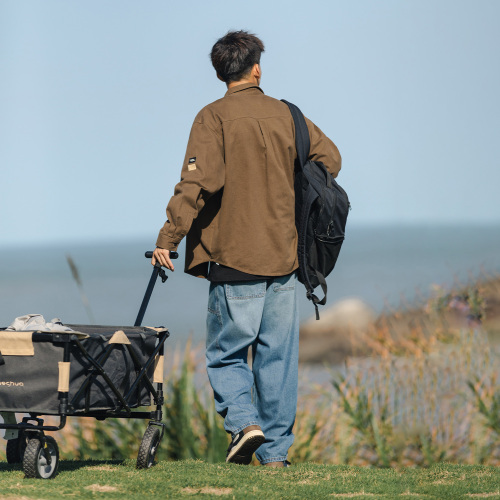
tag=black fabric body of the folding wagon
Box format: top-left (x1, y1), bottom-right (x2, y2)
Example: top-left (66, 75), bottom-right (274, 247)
top-left (0, 325), bottom-right (164, 416)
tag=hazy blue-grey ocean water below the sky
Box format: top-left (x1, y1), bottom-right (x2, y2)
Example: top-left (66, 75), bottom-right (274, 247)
top-left (0, 225), bottom-right (500, 344)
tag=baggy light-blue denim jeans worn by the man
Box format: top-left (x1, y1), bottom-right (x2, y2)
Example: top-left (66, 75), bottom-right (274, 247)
top-left (206, 273), bottom-right (299, 464)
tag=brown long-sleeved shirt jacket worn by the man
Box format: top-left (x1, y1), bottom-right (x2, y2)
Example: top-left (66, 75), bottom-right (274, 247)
top-left (156, 83), bottom-right (341, 277)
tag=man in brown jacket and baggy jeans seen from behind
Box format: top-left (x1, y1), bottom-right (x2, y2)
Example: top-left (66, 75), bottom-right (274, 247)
top-left (152, 31), bottom-right (341, 467)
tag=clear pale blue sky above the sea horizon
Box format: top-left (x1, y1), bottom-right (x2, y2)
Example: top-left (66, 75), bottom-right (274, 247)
top-left (0, 0), bottom-right (500, 246)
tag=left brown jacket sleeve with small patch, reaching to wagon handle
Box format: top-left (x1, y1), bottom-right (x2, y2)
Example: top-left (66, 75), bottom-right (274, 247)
top-left (156, 110), bottom-right (225, 250)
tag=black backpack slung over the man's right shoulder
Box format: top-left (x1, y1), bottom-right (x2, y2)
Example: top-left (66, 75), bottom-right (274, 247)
top-left (282, 99), bottom-right (351, 319)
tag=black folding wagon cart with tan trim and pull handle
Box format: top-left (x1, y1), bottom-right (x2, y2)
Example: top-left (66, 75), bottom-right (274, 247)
top-left (0, 252), bottom-right (177, 479)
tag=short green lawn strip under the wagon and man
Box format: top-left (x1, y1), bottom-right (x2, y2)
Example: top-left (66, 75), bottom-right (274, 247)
top-left (0, 460), bottom-right (500, 500)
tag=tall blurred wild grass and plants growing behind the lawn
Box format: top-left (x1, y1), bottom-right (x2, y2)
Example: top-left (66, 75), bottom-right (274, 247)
top-left (0, 278), bottom-right (500, 476)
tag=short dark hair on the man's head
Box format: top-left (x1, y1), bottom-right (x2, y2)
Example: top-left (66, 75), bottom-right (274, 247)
top-left (210, 30), bottom-right (264, 83)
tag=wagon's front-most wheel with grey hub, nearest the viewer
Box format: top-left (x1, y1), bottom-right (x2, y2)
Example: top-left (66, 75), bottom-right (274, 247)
top-left (23, 436), bottom-right (59, 479)
